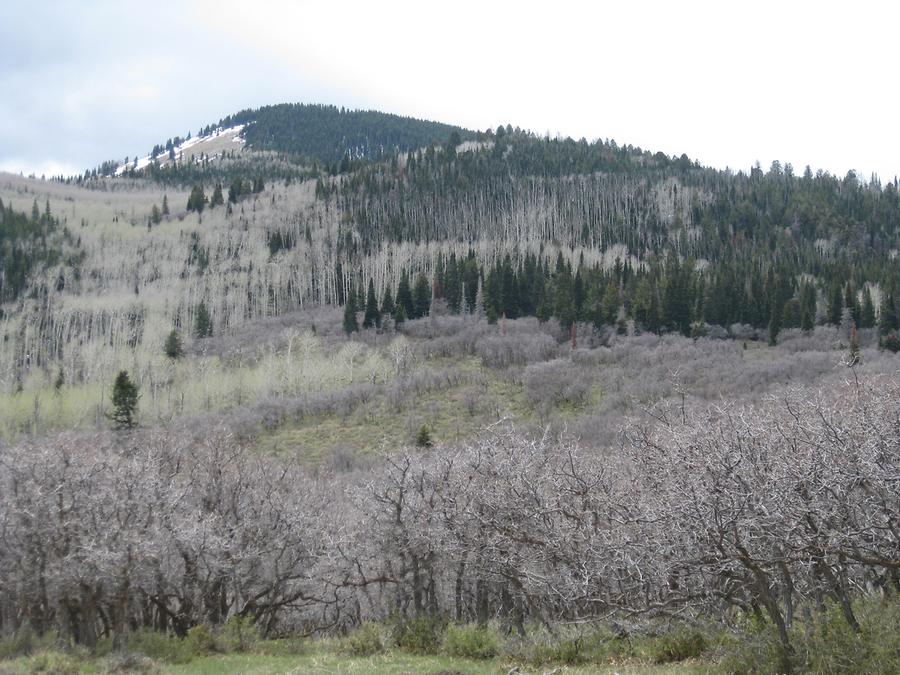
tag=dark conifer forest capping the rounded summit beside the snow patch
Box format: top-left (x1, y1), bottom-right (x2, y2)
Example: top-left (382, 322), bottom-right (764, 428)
top-left (219, 103), bottom-right (474, 165)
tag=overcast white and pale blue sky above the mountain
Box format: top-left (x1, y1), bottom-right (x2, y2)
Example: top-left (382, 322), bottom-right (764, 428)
top-left (0, 0), bottom-right (900, 180)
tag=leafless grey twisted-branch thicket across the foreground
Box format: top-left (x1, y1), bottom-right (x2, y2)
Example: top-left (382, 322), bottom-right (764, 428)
top-left (0, 377), bottom-right (900, 671)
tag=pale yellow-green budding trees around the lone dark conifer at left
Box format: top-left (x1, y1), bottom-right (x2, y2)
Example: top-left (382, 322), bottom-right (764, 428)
top-left (0, 334), bottom-right (391, 442)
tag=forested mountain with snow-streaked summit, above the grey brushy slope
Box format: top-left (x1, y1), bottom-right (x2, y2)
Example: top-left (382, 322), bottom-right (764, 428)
top-left (0, 105), bottom-right (900, 402)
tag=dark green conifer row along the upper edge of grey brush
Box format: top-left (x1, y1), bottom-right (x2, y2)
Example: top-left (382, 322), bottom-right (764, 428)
top-left (339, 252), bottom-right (898, 351)
